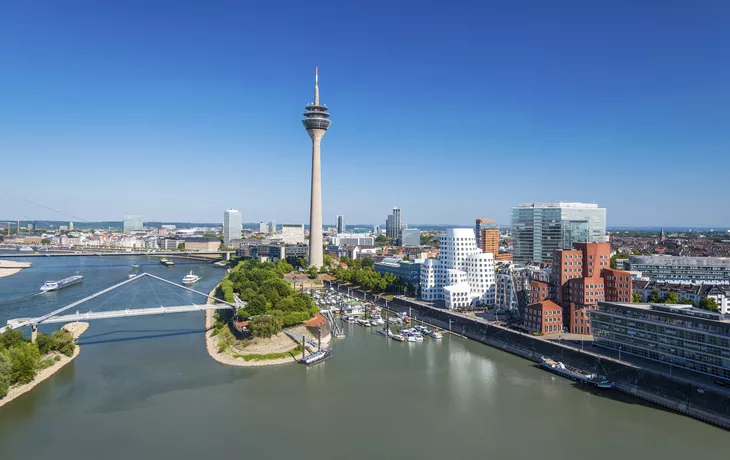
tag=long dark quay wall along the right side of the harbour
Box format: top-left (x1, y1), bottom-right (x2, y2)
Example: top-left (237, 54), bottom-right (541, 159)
top-left (330, 282), bottom-right (730, 430)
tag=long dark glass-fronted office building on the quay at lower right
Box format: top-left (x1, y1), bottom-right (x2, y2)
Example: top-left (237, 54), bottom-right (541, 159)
top-left (591, 302), bottom-right (730, 382)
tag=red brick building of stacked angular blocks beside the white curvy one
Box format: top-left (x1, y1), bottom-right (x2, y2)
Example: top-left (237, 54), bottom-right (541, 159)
top-left (552, 243), bottom-right (631, 334)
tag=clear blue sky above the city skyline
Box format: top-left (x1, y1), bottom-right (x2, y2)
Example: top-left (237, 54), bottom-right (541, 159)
top-left (0, 0), bottom-right (730, 226)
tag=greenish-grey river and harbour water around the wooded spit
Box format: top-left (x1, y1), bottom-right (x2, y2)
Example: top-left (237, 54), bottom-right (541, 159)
top-left (0, 257), bottom-right (730, 460)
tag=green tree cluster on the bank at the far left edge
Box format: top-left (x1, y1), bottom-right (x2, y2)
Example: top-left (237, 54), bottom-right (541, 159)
top-left (0, 329), bottom-right (76, 398)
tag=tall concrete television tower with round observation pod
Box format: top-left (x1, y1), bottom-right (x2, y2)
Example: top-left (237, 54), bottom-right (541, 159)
top-left (302, 68), bottom-right (332, 268)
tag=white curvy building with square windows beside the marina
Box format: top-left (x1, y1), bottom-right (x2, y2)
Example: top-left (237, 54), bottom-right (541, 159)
top-left (421, 228), bottom-right (496, 309)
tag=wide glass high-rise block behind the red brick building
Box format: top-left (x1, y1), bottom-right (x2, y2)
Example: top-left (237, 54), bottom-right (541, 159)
top-left (510, 202), bottom-right (608, 263)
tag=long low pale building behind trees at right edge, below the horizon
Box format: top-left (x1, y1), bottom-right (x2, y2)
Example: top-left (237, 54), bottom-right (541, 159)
top-left (629, 256), bottom-right (730, 284)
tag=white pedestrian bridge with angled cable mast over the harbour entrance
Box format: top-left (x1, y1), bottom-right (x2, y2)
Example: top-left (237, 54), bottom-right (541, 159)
top-left (0, 273), bottom-right (236, 340)
